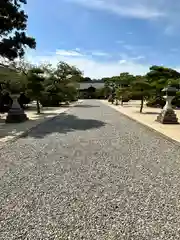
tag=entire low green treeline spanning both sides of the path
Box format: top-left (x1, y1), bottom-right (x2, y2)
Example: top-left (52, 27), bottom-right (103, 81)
top-left (0, 60), bottom-right (180, 112)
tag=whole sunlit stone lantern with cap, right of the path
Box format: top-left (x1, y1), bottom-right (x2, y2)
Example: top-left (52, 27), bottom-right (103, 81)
top-left (157, 86), bottom-right (178, 124)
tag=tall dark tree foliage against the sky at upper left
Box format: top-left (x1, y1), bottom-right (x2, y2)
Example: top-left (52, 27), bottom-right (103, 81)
top-left (0, 0), bottom-right (36, 60)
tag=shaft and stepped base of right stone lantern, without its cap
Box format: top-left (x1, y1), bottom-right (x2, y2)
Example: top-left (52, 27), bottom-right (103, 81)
top-left (157, 96), bottom-right (178, 124)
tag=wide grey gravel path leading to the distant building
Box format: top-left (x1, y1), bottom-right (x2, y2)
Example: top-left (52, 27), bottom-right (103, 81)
top-left (0, 100), bottom-right (180, 240)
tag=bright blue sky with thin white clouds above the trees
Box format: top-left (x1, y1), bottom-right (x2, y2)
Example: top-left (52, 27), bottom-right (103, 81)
top-left (25, 0), bottom-right (180, 78)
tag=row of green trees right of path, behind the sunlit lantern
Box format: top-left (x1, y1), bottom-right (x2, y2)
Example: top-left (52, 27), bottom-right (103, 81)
top-left (83, 66), bottom-right (180, 112)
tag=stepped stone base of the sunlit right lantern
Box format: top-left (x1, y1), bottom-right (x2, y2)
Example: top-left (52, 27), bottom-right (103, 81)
top-left (156, 109), bottom-right (179, 124)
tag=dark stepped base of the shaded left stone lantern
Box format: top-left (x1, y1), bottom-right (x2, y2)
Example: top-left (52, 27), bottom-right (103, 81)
top-left (6, 108), bottom-right (29, 123)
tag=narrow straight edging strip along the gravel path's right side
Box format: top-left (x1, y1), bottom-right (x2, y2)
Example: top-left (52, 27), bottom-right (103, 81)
top-left (101, 101), bottom-right (180, 147)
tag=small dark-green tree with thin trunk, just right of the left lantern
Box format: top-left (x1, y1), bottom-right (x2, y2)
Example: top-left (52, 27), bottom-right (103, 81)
top-left (27, 68), bottom-right (44, 114)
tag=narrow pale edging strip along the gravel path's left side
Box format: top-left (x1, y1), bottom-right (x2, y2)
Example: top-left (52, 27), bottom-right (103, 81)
top-left (0, 100), bottom-right (83, 147)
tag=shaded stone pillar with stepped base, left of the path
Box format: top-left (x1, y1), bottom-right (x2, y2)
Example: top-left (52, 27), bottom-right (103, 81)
top-left (6, 96), bottom-right (28, 123)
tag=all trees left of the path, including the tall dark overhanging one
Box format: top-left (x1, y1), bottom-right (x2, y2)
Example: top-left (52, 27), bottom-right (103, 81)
top-left (0, 0), bottom-right (85, 112)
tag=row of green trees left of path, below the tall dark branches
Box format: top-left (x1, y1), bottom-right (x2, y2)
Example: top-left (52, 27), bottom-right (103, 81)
top-left (0, 60), bottom-right (82, 113)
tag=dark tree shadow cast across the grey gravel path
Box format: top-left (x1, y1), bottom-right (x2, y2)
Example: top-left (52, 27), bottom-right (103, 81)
top-left (22, 113), bottom-right (106, 138)
